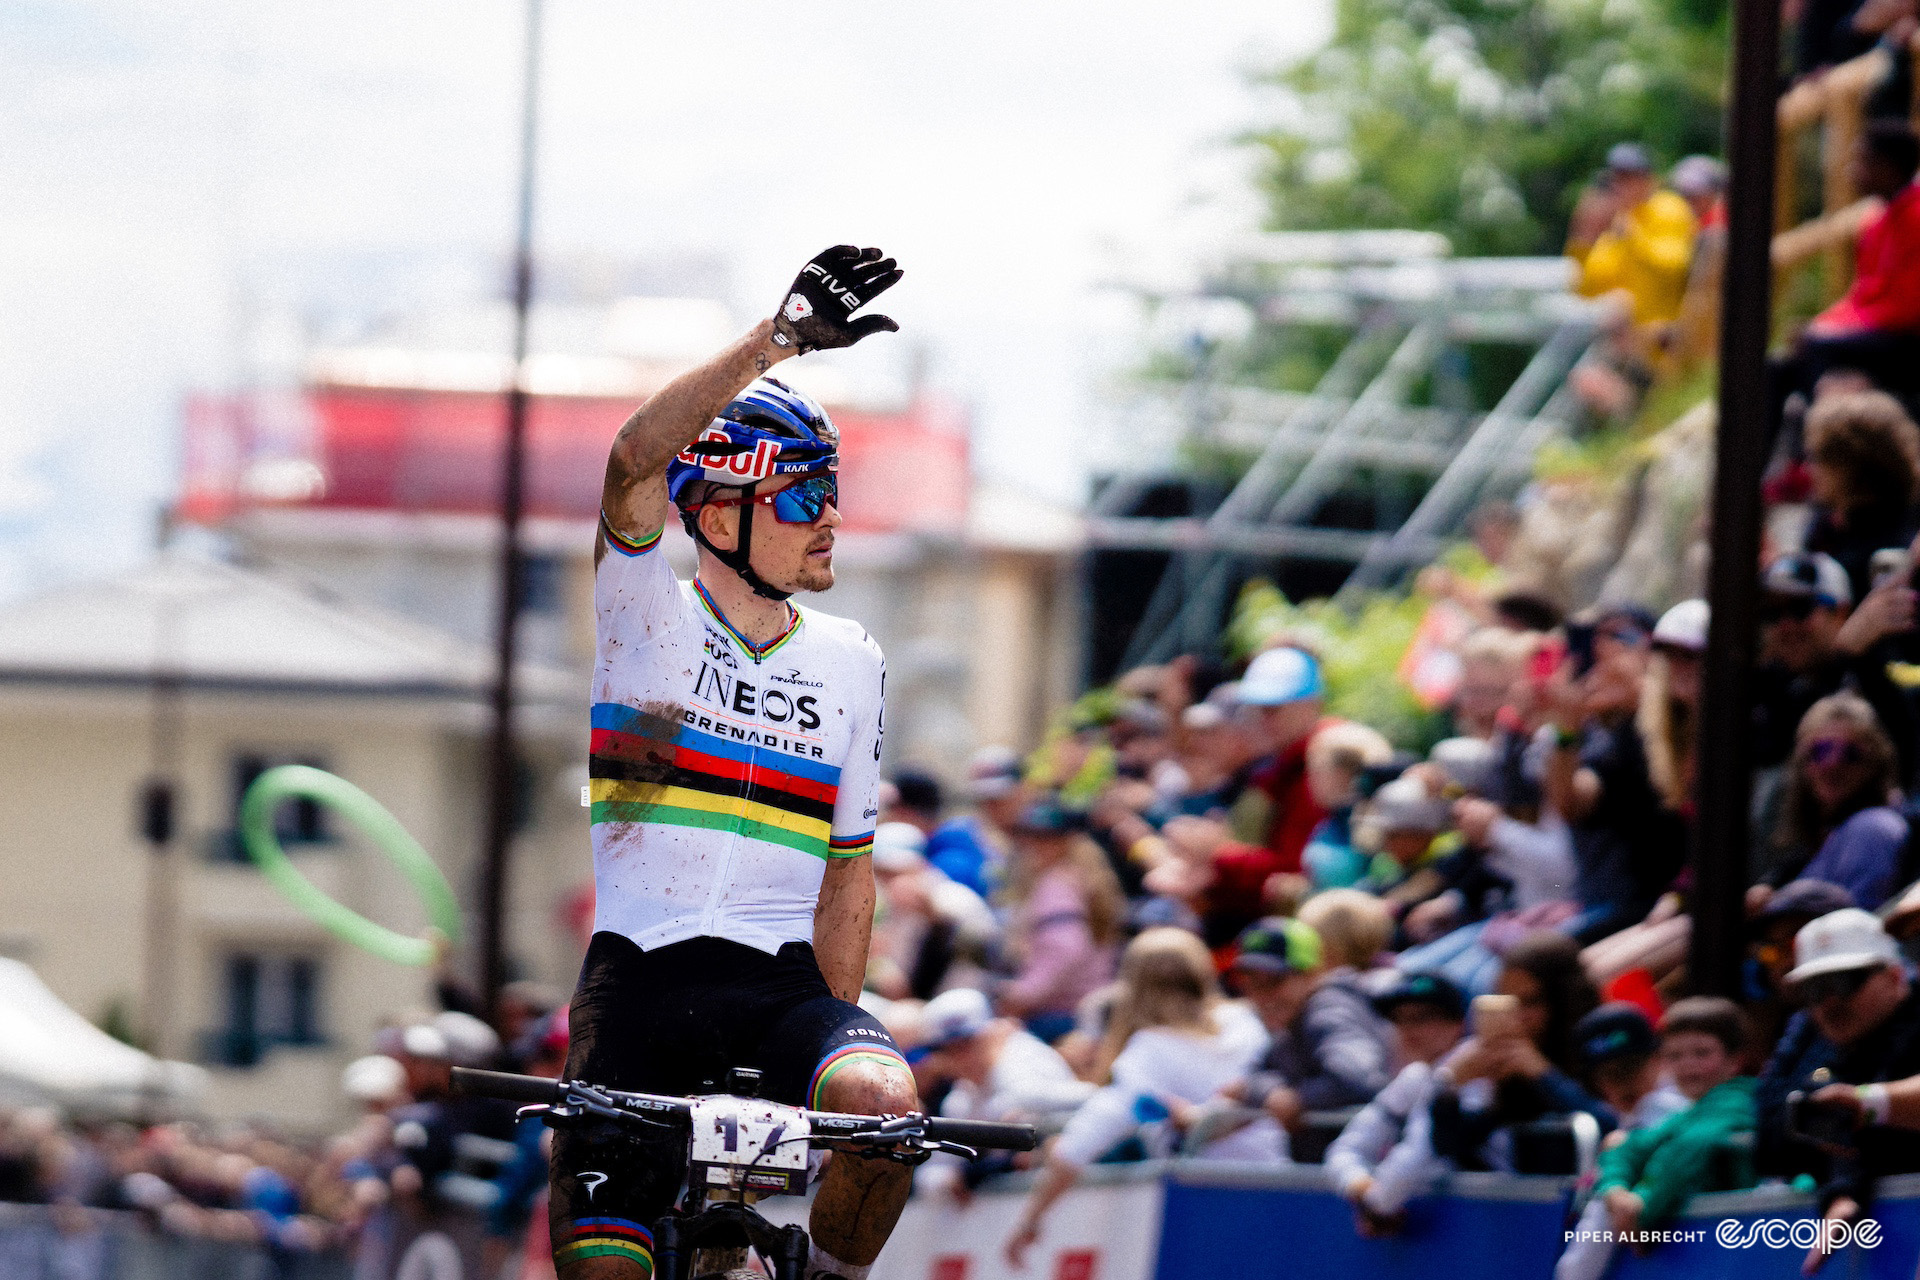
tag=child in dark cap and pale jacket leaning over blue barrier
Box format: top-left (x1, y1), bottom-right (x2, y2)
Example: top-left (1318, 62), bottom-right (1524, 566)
top-left (1325, 973), bottom-right (1467, 1236)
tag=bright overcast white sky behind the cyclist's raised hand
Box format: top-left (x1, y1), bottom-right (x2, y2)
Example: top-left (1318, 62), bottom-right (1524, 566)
top-left (0, 0), bottom-right (1329, 595)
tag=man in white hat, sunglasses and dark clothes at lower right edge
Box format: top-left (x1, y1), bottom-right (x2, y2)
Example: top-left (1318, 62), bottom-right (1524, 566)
top-left (1753, 908), bottom-right (1920, 1267)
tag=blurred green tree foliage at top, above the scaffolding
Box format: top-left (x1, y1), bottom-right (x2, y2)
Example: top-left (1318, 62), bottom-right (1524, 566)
top-left (1250, 0), bottom-right (1726, 255)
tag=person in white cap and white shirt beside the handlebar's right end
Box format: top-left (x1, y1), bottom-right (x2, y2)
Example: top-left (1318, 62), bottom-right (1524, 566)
top-left (914, 986), bottom-right (1094, 1199)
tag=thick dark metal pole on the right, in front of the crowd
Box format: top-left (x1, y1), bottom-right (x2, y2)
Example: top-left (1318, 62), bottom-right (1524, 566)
top-left (1688, 0), bottom-right (1780, 996)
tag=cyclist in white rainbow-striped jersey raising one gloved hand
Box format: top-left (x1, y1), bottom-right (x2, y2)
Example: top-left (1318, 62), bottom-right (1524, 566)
top-left (549, 246), bottom-right (918, 1280)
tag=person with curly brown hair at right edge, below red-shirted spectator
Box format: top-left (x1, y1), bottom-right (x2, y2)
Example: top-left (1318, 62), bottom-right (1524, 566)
top-left (1805, 387), bottom-right (1920, 601)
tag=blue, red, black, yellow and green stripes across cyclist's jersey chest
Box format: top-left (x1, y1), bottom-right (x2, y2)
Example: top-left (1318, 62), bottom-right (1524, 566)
top-left (588, 702), bottom-right (844, 858)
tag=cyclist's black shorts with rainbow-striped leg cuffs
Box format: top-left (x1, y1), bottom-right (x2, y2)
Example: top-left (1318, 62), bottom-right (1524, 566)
top-left (547, 933), bottom-right (906, 1265)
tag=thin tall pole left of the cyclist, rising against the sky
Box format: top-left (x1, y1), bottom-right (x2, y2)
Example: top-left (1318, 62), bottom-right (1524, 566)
top-left (480, 0), bottom-right (541, 1013)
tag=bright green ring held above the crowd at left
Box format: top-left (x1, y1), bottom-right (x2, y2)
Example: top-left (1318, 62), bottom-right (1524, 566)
top-left (240, 764), bottom-right (461, 965)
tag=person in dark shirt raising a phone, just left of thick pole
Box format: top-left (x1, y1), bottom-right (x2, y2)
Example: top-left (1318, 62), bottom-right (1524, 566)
top-left (1546, 606), bottom-right (1684, 942)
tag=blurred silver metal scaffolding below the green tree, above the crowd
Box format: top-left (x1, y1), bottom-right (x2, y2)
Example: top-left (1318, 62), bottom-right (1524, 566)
top-left (1089, 232), bottom-right (1597, 666)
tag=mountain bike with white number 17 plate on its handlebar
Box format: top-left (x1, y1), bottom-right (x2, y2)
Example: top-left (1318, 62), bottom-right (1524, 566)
top-left (453, 1067), bottom-right (1039, 1280)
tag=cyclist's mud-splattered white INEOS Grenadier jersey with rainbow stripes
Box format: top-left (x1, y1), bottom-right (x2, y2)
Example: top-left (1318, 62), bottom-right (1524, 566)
top-left (589, 530), bottom-right (887, 952)
